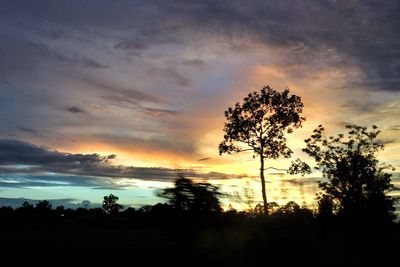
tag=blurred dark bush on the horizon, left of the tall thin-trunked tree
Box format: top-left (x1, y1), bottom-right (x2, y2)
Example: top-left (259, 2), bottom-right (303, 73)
top-left (158, 176), bottom-right (222, 213)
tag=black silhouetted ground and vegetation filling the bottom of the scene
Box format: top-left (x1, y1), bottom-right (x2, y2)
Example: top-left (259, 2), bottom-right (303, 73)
top-left (0, 199), bottom-right (400, 266)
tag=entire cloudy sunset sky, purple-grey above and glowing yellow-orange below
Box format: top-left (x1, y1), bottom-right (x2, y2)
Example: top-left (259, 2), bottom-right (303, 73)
top-left (0, 0), bottom-right (400, 209)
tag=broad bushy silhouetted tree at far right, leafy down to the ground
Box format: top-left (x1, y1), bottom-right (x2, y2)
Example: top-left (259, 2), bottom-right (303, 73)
top-left (303, 124), bottom-right (395, 221)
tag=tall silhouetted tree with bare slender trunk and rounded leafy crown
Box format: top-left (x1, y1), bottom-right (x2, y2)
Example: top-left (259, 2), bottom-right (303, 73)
top-left (219, 86), bottom-right (305, 215)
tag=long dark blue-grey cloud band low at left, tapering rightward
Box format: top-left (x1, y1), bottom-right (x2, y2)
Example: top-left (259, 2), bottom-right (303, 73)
top-left (0, 140), bottom-right (247, 189)
